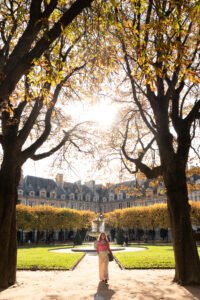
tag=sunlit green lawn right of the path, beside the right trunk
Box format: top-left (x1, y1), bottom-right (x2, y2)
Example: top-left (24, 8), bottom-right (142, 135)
top-left (114, 245), bottom-right (200, 269)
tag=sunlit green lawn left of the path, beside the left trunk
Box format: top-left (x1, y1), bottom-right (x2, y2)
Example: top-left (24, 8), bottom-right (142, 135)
top-left (17, 246), bottom-right (84, 270)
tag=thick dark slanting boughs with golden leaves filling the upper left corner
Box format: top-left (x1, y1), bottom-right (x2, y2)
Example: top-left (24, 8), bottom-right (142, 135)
top-left (0, 0), bottom-right (93, 107)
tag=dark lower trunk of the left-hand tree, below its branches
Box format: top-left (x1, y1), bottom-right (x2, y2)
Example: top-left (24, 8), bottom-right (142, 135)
top-left (0, 169), bottom-right (17, 289)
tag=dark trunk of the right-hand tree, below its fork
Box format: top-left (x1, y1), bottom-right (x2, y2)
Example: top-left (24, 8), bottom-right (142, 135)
top-left (164, 168), bottom-right (200, 285)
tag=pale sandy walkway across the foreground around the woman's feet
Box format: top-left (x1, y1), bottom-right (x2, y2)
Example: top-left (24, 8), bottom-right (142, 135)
top-left (0, 254), bottom-right (200, 300)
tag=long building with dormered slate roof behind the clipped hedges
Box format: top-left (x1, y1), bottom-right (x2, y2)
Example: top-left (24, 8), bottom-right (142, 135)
top-left (18, 174), bottom-right (200, 213)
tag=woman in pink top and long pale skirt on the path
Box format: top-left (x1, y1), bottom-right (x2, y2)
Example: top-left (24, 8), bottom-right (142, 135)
top-left (97, 232), bottom-right (112, 283)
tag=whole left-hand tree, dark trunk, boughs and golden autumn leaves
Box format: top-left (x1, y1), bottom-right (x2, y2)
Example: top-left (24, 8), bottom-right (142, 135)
top-left (0, 0), bottom-right (96, 288)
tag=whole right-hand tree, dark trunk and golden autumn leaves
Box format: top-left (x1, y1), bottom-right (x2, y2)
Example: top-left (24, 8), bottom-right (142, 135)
top-left (101, 0), bottom-right (200, 284)
